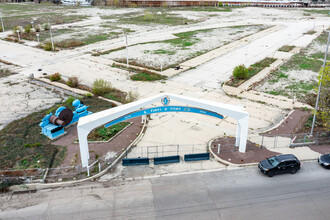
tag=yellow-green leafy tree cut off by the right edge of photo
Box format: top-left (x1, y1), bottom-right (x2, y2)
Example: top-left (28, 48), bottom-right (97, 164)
top-left (317, 63), bottom-right (330, 132)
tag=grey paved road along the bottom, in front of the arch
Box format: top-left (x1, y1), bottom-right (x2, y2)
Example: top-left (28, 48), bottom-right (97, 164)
top-left (0, 161), bottom-right (330, 220)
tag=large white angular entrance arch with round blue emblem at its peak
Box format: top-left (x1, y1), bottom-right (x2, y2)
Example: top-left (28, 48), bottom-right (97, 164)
top-left (77, 93), bottom-right (249, 167)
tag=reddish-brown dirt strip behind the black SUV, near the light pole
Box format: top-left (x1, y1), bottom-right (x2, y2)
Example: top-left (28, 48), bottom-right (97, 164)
top-left (262, 109), bottom-right (311, 137)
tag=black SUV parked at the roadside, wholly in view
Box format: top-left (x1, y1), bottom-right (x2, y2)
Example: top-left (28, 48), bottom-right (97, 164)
top-left (258, 154), bottom-right (300, 177)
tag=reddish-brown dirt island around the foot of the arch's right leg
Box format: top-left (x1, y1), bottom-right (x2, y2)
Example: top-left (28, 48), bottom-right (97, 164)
top-left (211, 137), bottom-right (279, 164)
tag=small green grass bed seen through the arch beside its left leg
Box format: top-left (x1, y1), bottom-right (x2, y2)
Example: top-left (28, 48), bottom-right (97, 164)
top-left (88, 122), bottom-right (130, 141)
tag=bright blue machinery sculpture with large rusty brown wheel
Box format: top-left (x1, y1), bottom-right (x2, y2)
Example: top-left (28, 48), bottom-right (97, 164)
top-left (39, 99), bottom-right (92, 140)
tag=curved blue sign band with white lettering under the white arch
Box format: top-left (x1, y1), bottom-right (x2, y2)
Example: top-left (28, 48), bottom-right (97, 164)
top-left (104, 106), bottom-right (223, 128)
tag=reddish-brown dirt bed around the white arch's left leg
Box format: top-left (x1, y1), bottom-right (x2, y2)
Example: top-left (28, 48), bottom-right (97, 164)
top-left (52, 117), bottom-right (143, 167)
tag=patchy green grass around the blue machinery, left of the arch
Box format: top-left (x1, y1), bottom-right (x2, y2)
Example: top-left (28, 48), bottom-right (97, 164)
top-left (0, 98), bottom-right (112, 169)
